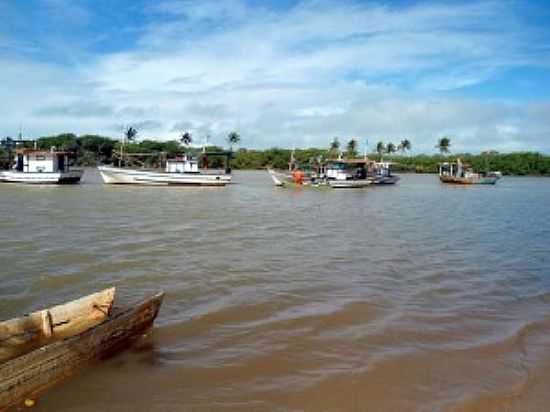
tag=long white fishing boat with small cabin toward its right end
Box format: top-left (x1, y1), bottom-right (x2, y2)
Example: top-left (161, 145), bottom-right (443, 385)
top-left (98, 153), bottom-right (231, 186)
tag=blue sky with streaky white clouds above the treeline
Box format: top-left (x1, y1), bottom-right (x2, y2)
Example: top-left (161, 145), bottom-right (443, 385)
top-left (0, 0), bottom-right (550, 153)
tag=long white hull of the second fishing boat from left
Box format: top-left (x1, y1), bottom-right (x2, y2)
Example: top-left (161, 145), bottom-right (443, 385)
top-left (98, 166), bottom-right (231, 186)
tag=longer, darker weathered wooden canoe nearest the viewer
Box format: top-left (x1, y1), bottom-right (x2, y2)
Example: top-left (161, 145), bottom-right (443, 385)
top-left (0, 293), bottom-right (164, 411)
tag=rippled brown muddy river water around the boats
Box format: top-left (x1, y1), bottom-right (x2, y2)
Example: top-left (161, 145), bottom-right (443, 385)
top-left (0, 170), bottom-right (550, 412)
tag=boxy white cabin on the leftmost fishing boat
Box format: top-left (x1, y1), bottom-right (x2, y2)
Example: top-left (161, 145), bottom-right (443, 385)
top-left (13, 148), bottom-right (69, 173)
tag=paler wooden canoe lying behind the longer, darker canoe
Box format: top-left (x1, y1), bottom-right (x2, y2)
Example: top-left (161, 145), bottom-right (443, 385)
top-left (0, 288), bottom-right (115, 363)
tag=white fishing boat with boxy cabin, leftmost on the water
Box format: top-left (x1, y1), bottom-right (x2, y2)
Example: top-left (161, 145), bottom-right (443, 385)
top-left (0, 148), bottom-right (84, 184)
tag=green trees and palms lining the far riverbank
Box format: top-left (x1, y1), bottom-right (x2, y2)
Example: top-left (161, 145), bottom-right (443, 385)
top-left (0, 134), bottom-right (550, 175)
